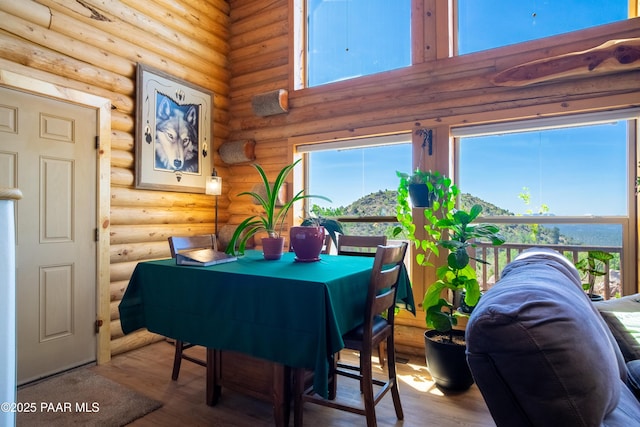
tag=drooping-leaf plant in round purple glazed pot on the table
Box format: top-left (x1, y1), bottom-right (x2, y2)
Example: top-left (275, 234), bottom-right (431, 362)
top-left (289, 216), bottom-right (344, 261)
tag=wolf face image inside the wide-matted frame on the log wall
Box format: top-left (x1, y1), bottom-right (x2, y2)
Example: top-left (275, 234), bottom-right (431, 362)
top-left (154, 92), bottom-right (200, 173)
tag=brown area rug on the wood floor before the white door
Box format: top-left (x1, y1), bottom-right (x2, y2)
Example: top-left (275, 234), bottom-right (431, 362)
top-left (16, 368), bottom-right (162, 427)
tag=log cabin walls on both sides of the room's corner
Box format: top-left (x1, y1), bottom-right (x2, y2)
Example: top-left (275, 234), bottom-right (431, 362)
top-left (0, 0), bottom-right (640, 361)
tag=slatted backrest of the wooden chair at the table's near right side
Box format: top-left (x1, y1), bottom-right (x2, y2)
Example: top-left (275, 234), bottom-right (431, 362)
top-left (364, 242), bottom-right (408, 338)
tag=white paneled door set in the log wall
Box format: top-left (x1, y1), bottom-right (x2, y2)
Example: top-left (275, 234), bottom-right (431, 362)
top-left (0, 88), bottom-right (97, 384)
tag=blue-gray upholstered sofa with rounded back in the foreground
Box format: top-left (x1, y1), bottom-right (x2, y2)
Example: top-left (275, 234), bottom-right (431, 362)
top-left (466, 248), bottom-right (640, 427)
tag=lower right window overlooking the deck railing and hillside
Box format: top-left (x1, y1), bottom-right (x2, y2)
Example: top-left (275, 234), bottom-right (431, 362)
top-left (452, 110), bottom-right (639, 296)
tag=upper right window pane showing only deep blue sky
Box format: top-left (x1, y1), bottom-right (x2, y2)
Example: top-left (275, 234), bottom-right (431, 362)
top-left (457, 0), bottom-right (629, 55)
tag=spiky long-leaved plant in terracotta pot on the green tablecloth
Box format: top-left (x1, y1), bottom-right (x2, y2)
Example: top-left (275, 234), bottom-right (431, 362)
top-left (226, 160), bottom-right (331, 260)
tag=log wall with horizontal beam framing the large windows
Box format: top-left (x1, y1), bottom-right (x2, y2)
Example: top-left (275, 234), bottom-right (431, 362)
top-left (228, 0), bottom-right (640, 353)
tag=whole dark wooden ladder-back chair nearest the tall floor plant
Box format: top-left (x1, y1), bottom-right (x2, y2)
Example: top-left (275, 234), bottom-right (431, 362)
top-left (294, 242), bottom-right (408, 427)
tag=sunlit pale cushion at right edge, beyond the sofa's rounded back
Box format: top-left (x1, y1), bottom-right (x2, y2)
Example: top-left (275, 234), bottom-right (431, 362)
top-left (594, 294), bottom-right (640, 361)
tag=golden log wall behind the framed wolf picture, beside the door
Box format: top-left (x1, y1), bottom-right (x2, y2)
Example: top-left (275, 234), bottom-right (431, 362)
top-left (0, 0), bottom-right (230, 360)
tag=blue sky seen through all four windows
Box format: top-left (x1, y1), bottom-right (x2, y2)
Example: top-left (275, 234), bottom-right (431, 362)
top-left (310, 0), bottom-right (628, 215)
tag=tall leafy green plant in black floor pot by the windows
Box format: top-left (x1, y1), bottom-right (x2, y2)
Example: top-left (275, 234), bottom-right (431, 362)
top-left (394, 173), bottom-right (504, 390)
